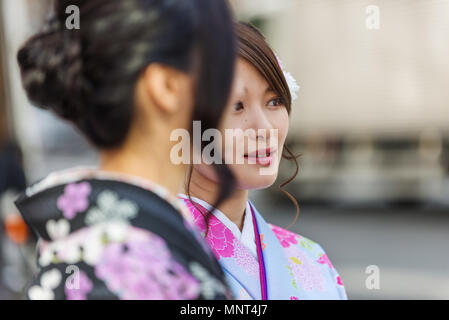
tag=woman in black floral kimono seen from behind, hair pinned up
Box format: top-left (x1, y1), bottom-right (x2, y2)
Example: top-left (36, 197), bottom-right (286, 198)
top-left (16, 0), bottom-right (235, 300)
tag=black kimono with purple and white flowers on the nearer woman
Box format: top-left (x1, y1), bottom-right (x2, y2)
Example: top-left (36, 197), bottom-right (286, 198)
top-left (16, 169), bottom-right (232, 300)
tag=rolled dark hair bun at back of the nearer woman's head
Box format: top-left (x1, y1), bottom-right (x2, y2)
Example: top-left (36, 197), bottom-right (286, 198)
top-left (18, 21), bottom-right (82, 121)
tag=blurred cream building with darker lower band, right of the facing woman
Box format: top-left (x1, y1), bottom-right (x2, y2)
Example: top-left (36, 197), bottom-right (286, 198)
top-left (234, 0), bottom-right (449, 206)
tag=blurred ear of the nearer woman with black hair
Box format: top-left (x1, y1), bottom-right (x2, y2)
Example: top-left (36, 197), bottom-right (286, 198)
top-left (143, 63), bottom-right (192, 114)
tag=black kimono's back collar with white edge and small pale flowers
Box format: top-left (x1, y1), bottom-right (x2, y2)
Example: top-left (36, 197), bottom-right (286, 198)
top-left (15, 168), bottom-right (199, 241)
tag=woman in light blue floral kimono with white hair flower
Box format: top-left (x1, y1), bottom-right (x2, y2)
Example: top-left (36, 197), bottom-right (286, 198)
top-left (180, 24), bottom-right (347, 300)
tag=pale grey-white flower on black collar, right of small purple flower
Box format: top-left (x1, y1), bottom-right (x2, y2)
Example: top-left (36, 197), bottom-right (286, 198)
top-left (85, 190), bottom-right (139, 225)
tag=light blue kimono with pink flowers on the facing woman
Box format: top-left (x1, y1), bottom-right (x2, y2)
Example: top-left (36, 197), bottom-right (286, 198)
top-left (183, 199), bottom-right (347, 300)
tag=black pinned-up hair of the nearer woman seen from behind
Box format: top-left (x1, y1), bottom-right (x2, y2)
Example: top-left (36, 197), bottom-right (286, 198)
top-left (18, 0), bottom-right (236, 202)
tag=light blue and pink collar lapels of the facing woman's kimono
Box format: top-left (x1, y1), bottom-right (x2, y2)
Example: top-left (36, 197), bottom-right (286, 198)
top-left (180, 199), bottom-right (298, 300)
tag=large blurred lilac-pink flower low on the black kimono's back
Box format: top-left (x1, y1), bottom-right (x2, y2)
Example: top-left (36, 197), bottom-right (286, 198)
top-left (95, 230), bottom-right (200, 300)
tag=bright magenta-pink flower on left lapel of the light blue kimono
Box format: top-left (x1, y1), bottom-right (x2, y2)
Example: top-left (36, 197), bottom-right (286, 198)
top-left (184, 200), bottom-right (234, 260)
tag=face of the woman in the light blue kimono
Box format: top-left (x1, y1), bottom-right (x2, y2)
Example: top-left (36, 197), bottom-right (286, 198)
top-left (196, 58), bottom-right (289, 190)
